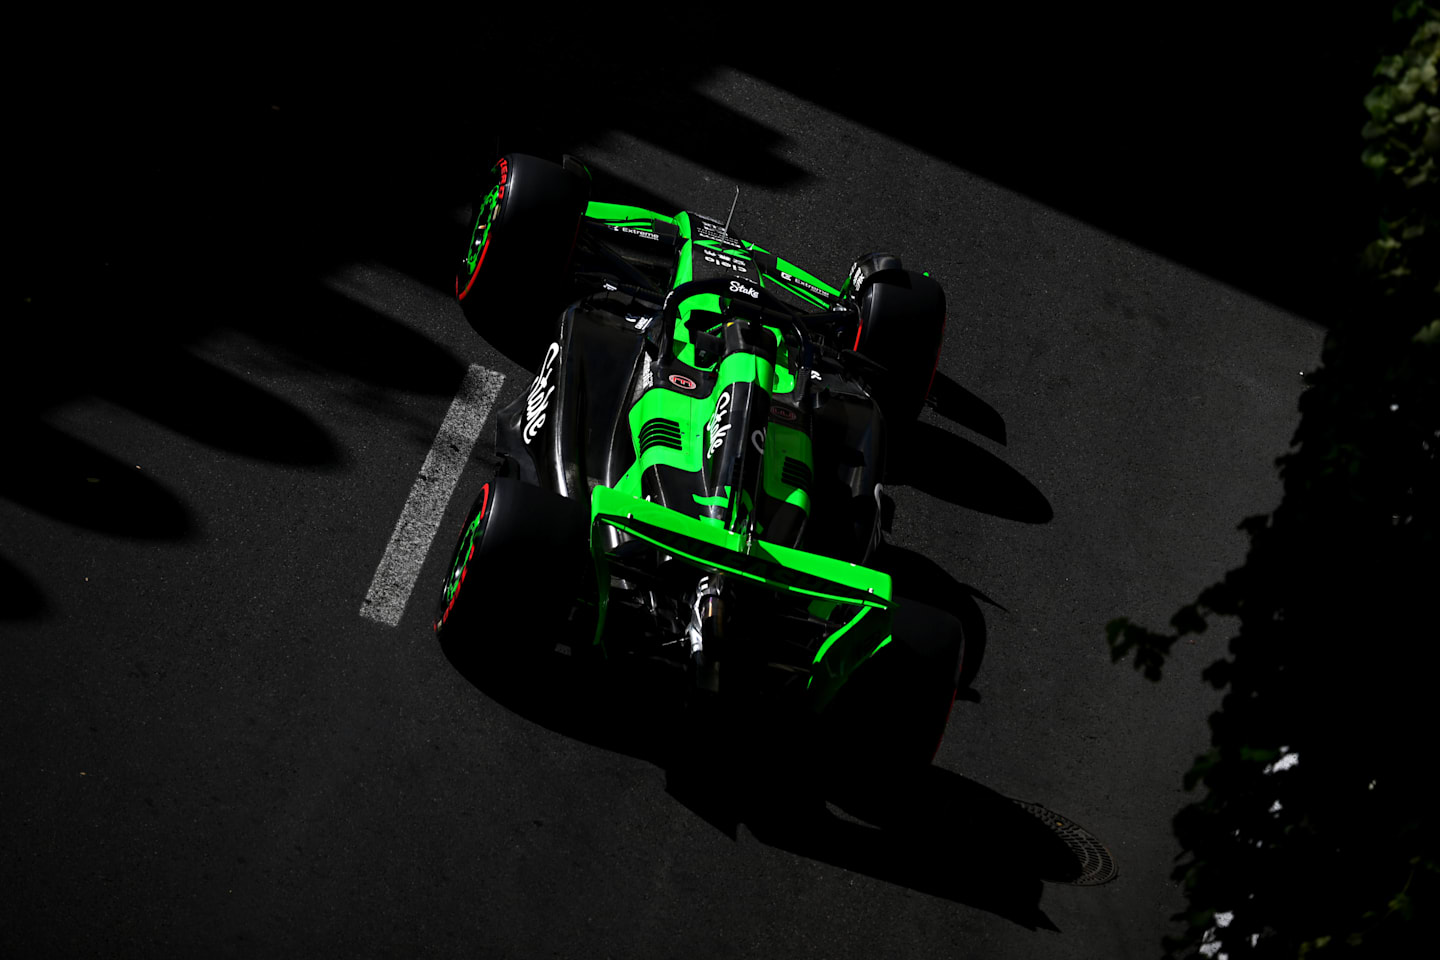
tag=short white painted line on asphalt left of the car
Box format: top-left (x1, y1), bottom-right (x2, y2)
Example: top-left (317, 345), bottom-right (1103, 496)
top-left (360, 364), bottom-right (505, 626)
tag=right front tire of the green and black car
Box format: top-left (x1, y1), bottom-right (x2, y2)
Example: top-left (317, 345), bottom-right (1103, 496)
top-left (845, 253), bottom-right (945, 429)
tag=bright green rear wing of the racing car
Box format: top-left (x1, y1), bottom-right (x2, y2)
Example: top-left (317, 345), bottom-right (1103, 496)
top-left (590, 486), bottom-right (893, 708)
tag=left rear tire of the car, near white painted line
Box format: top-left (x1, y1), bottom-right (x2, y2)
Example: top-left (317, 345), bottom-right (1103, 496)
top-left (432, 476), bottom-right (593, 666)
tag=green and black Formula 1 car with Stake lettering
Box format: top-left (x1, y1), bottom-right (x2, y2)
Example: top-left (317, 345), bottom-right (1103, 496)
top-left (433, 154), bottom-right (963, 764)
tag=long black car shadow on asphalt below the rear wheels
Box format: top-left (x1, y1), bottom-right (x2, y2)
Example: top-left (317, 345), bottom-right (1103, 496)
top-left (446, 616), bottom-right (1115, 930)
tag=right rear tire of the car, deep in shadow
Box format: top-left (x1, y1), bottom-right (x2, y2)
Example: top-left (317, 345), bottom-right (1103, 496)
top-left (821, 599), bottom-right (965, 776)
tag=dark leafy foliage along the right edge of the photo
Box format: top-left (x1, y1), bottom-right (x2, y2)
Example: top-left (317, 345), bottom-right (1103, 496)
top-left (1107, 1), bottom-right (1440, 957)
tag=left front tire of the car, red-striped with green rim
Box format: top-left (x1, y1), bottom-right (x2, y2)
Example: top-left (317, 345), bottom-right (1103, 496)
top-left (455, 154), bottom-right (590, 345)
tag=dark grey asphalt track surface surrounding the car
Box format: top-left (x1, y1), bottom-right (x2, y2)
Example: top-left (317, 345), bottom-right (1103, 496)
top-left (0, 18), bottom-right (1348, 957)
